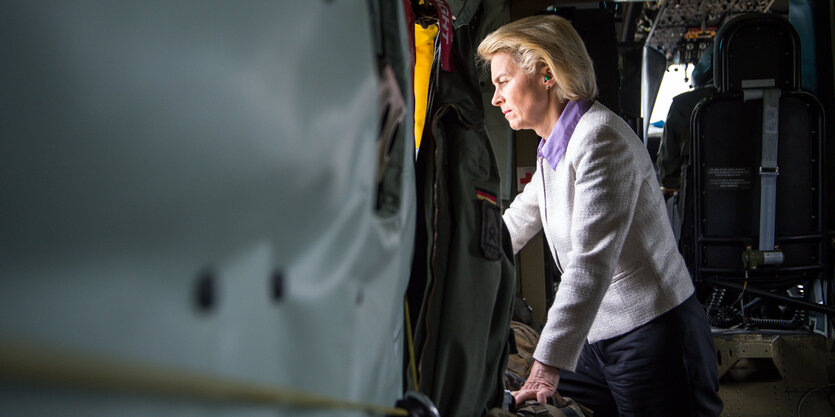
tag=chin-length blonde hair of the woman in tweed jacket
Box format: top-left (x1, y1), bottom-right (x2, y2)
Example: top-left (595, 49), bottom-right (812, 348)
top-left (478, 15), bottom-right (597, 102)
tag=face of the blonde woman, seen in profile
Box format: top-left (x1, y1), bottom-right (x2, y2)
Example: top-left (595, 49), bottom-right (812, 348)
top-left (490, 53), bottom-right (554, 130)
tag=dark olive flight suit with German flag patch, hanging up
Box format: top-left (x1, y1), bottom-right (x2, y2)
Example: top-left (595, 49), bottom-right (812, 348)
top-left (408, 1), bottom-right (516, 417)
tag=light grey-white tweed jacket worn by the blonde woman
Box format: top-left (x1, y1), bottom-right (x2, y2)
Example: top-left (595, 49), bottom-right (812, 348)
top-left (504, 102), bottom-right (694, 371)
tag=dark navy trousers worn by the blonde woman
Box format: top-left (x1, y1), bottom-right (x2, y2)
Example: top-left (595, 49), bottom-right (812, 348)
top-left (557, 295), bottom-right (722, 417)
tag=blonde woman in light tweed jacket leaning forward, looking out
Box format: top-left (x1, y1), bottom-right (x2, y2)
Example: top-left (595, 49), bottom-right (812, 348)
top-left (478, 16), bottom-right (722, 417)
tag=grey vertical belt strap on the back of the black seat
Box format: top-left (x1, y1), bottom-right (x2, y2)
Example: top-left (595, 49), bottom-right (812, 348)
top-left (742, 79), bottom-right (783, 269)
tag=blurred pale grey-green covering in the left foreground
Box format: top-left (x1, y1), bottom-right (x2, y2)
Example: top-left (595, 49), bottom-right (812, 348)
top-left (0, 0), bottom-right (415, 416)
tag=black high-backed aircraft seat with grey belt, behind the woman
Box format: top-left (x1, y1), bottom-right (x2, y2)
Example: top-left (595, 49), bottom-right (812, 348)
top-left (681, 13), bottom-right (826, 329)
